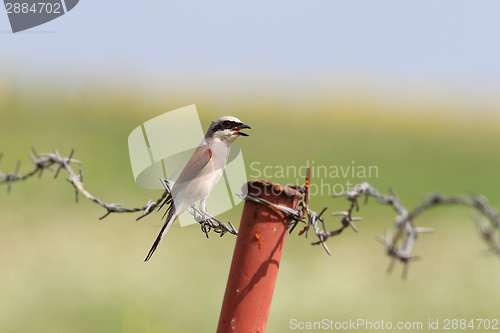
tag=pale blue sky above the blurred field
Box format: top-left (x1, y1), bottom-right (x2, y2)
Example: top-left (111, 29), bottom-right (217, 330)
top-left (0, 0), bottom-right (500, 100)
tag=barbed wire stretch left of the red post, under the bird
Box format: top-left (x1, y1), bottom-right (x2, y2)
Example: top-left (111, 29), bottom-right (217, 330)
top-left (0, 148), bottom-right (238, 238)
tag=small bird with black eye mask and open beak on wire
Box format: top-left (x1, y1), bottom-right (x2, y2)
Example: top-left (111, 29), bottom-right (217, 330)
top-left (144, 116), bottom-right (251, 262)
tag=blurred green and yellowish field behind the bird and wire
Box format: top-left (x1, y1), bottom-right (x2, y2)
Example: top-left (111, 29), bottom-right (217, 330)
top-left (0, 83), bottom-right (500, 333)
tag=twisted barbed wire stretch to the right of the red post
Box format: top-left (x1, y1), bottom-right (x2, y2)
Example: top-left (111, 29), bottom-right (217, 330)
top-left (240, 169), bottom-right (500, 279)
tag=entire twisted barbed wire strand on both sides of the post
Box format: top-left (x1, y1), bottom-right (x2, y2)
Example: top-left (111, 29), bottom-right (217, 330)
top-left (0, 148), bottom-right (500, 278)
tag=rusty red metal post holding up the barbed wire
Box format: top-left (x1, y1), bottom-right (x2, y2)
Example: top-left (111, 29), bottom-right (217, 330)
top-left (217, 180), bottom-right (302, 333)
